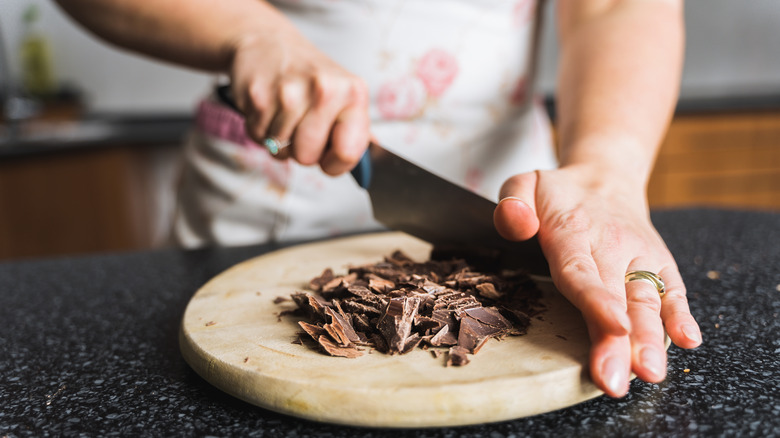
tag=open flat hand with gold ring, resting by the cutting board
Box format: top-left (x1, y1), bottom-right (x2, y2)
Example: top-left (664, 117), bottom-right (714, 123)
top-left (494, 165), bottom-right (701, 397)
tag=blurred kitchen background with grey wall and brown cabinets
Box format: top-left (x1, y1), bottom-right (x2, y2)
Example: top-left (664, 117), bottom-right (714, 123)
top-left (0, 0), bottom-right (780, 260)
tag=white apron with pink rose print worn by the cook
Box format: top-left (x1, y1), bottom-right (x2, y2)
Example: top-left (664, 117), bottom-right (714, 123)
top-left (175, 0), bottom-right (556, 247)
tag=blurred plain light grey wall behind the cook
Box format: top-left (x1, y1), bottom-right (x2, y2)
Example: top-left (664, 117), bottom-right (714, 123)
top-left (0, 0), bottom-right (780, 112)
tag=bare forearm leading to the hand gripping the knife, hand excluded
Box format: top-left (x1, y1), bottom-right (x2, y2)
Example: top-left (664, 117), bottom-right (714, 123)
top-left (57, 0), bottom-right (297, 71)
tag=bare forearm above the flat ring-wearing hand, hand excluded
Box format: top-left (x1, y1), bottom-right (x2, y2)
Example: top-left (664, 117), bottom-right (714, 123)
top-left (558, 0), bottom-right (684, 188)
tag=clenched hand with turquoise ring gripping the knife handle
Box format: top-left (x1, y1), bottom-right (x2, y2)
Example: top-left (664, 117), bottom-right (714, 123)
top-left (230, 31), bottom-right (370, 175)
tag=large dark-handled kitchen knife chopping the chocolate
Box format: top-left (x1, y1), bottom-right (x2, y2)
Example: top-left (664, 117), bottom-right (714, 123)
top-left (216, 85), bottom-right (550, 276)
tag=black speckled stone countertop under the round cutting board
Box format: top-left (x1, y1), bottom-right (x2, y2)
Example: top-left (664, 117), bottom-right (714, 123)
top-left (0, 209), bottom-right (780, 437)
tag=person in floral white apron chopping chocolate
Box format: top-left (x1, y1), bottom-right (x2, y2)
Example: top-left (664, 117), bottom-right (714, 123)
top-left (58, 0), bottom-right (702, 397)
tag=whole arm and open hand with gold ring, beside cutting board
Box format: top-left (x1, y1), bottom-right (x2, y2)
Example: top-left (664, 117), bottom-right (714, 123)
top-left (495, 0), bottom-right (701, 397)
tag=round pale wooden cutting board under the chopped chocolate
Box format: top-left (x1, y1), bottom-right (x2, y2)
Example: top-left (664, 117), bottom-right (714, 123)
top-left (180, 232), bottom-right (601, 427)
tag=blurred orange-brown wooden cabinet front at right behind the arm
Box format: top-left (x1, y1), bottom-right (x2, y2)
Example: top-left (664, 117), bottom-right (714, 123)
top-left (648, 111), bottom-right (780, 210)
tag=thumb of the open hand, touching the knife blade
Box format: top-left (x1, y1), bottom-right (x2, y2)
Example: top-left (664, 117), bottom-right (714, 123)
top-left (493, 172), bottom-right (539, 241)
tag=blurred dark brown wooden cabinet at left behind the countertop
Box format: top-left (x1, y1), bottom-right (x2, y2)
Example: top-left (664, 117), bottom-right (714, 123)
top-left (0, 145), bottom-right (178, 259)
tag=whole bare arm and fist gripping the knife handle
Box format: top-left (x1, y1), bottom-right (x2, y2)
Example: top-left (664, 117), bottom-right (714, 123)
top-left (57, 0), bottom-right (369, 174)
